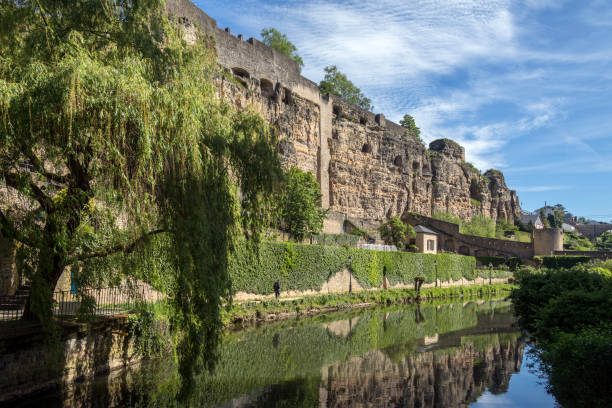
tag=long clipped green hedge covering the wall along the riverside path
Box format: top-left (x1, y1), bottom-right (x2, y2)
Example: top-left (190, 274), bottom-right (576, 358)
top-left (229, 242), bottom-right (476, 294)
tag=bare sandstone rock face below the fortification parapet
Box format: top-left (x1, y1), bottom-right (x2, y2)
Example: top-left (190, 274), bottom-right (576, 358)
top-left (218, 76), bottom-right (520, 226)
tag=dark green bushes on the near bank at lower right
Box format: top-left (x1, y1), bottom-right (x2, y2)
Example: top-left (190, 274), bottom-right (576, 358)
top-left (511, 262), bottom-right (612, 407)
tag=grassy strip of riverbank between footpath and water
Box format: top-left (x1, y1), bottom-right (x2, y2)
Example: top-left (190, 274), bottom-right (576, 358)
top-left (222, 283), bottom-right (514, 329)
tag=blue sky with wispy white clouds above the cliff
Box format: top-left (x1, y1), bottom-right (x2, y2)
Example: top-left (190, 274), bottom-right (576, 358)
top-left (194, 0), bottom-right (612, 220)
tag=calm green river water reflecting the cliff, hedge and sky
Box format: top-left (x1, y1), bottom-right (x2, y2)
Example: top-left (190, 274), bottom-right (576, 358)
top-left (9, 300), bottom-right (555, 408)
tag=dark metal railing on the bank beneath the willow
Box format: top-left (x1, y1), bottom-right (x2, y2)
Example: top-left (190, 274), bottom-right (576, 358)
top-left (0, 285), bottom-right (163, 321)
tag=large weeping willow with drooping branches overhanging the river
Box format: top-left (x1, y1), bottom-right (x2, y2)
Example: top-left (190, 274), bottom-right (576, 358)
top-left (0, 0), bottom-right (280, 394)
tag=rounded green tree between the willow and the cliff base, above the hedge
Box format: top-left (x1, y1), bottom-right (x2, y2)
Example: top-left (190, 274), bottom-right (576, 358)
top-left (277, 167), bottom-right (327, 241)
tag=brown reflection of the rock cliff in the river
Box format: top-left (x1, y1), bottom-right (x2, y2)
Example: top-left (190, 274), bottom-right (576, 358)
top-left (319, 340), bottom-right (523, 407)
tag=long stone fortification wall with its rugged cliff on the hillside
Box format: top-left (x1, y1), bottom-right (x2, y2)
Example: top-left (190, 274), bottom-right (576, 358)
top-left (167, 0), bottom-right (520, 223)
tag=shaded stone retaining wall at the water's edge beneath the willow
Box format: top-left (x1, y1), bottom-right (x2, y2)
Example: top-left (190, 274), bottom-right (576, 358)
top-left (0, 316), bottom-right (138, 403)
